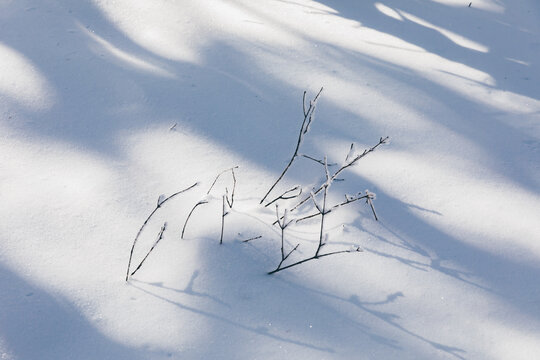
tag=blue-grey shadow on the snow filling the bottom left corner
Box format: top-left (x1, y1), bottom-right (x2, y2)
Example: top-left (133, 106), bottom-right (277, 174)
top-left (0, 266), bottom-right (150, 360)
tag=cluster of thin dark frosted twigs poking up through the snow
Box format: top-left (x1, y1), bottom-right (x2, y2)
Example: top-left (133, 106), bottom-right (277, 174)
top-left (125, 88), bottom-right (389, 281)
